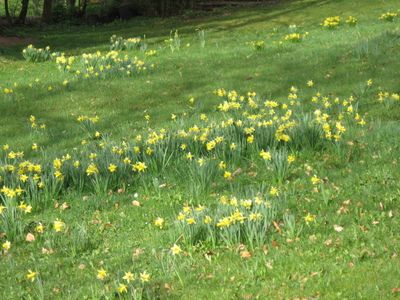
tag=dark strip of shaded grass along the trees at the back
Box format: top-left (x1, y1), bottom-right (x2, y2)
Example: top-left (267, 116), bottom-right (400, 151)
top-left (0, 0), bottom-right (333, 60)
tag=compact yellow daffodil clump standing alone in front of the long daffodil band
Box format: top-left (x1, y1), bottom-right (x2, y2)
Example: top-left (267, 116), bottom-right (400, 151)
top-left (171, 192), bottom-right (282, 247)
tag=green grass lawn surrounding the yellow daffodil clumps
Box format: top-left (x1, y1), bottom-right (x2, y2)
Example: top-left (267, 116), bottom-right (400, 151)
top-left (0, 0), bottom-right (400, 299)
